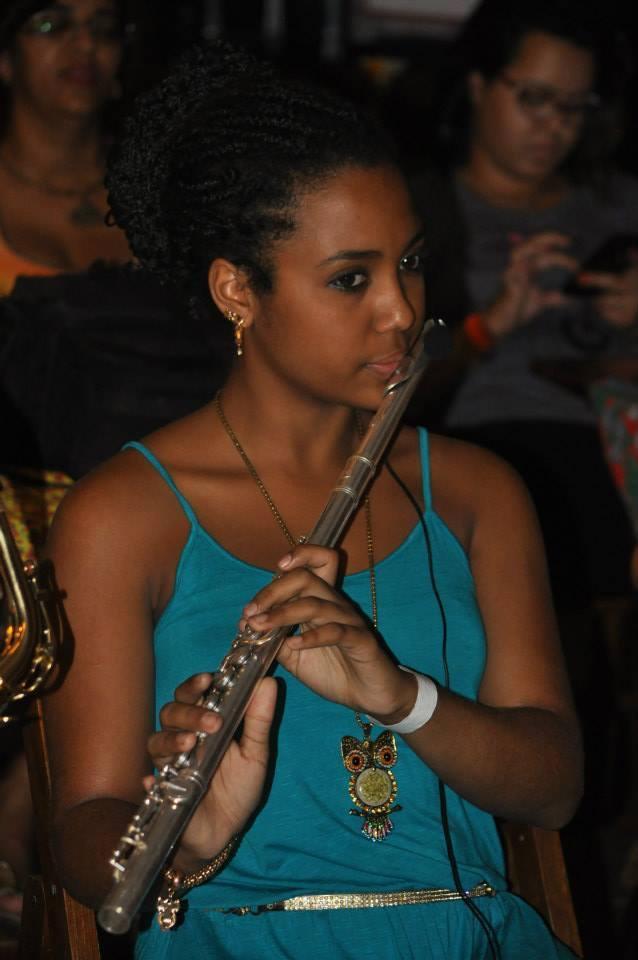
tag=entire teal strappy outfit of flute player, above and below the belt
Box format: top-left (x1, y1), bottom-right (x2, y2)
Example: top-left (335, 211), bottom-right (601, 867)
top-left (129, 430), bottom-right (575, 960)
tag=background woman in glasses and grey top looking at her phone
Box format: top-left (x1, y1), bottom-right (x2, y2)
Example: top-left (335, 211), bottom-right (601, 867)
top-left (414, 0), bottom-right (638, 956)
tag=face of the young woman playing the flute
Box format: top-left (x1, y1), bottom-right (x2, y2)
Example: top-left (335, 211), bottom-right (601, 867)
top-left (245, 167), bottom-right (425, 409)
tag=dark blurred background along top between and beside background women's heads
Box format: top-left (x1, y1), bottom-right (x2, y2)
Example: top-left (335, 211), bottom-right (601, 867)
top-left (120, 0), bottom-right (638, 173)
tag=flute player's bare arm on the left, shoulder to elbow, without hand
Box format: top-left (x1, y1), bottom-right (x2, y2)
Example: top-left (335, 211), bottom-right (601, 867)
top-left (44, 470), bottom-right (158, 906)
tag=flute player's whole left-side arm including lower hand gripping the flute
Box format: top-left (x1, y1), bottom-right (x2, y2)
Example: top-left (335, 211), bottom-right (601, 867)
top-left (45, 454), bottom-right (275, 907)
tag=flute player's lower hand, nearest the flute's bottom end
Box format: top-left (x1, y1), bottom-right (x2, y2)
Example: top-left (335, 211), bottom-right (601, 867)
top-left (145, 673), bottom-right (277, 872)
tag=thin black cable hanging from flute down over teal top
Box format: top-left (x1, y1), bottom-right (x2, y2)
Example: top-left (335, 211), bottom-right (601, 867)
top-left (386, 461), bottom-right (501, 960)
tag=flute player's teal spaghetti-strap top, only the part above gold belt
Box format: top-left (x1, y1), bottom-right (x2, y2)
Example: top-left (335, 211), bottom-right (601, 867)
top-left (129, 430), bottom-right (505, 908)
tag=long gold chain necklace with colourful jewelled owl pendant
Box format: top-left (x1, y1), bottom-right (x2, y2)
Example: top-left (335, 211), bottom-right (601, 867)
top-left (214, 391), bottom-right (401, 841)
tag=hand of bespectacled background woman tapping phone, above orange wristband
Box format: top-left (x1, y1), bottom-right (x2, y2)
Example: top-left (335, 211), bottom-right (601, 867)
top-left (482, 231), bottom-right (579, 340)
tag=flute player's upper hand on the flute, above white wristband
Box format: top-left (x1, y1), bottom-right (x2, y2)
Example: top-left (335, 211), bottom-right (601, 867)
top-left (243, 544), bottom-right (416, 723)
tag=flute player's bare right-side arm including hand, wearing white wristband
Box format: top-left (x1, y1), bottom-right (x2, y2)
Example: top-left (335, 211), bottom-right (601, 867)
top-left (245, 440), bottom-right (582, 827)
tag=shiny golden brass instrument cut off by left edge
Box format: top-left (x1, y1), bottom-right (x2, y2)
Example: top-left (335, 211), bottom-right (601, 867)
top-left (0, 501), bottom-right (62, 724)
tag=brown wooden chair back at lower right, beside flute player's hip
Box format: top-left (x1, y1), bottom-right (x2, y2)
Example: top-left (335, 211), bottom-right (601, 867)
top-left (500, 822), bottom-right (583, 957)
